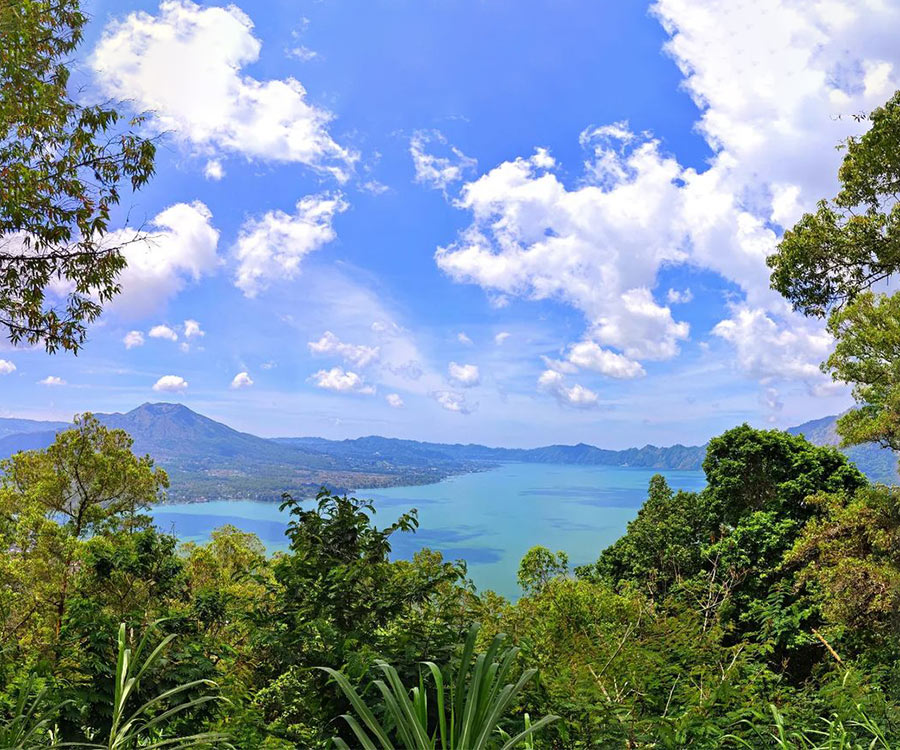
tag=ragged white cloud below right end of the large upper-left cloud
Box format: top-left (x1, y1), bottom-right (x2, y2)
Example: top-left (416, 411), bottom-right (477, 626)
top-left (234, 195), bottom-right (347, 297)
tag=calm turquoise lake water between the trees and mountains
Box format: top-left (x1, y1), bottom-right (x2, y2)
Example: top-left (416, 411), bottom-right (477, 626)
top-left (154, 463), bottom-right (705, 597)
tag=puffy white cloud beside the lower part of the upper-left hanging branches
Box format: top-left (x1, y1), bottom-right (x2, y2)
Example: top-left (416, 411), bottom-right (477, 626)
top-left (104, 201), bottom-right (219, 317)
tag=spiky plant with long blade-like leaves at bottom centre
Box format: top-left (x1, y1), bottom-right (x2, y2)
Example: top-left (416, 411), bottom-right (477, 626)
top-left (322, 624), bottom-right (559, 750)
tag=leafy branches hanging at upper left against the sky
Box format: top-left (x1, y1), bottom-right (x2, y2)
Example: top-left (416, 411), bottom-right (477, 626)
top-left (0, 0), bottom-right (156, 352)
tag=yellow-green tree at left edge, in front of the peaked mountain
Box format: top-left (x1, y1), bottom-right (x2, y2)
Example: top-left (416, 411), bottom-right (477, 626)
top-left (0, 414), bottom-right (168, 648)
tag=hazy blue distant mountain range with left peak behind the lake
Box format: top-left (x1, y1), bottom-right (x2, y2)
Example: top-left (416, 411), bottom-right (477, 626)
top-left (0, 403), bottom-right (900, 502)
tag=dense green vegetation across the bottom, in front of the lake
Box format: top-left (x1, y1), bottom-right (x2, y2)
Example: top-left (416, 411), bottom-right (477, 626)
top-left (0, 415), bottom-right (900, 750)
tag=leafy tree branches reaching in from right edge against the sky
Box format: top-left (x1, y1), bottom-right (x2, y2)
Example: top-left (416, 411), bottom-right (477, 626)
top-left (768, 91), bottom-right (900, 462)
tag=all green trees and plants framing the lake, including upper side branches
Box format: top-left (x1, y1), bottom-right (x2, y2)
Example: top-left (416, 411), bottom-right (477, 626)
top-left (0, 0), bottom-right (900, 750)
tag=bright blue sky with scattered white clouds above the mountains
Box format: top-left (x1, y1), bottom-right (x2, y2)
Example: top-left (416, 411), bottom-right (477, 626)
top-left (0, 0), bottom-right (900, 448)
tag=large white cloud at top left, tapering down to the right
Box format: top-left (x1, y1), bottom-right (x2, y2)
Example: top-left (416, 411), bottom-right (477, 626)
top-left (91, 0), bottom-right (356, 180)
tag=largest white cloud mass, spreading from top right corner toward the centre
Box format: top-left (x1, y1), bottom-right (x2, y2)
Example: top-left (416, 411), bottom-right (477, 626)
top-left (435, 0), bottom-right (900, 394)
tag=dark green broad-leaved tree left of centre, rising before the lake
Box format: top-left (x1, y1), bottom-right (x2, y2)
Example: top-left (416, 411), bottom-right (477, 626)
top-left (255, 489), bottom-right (465, 747)
